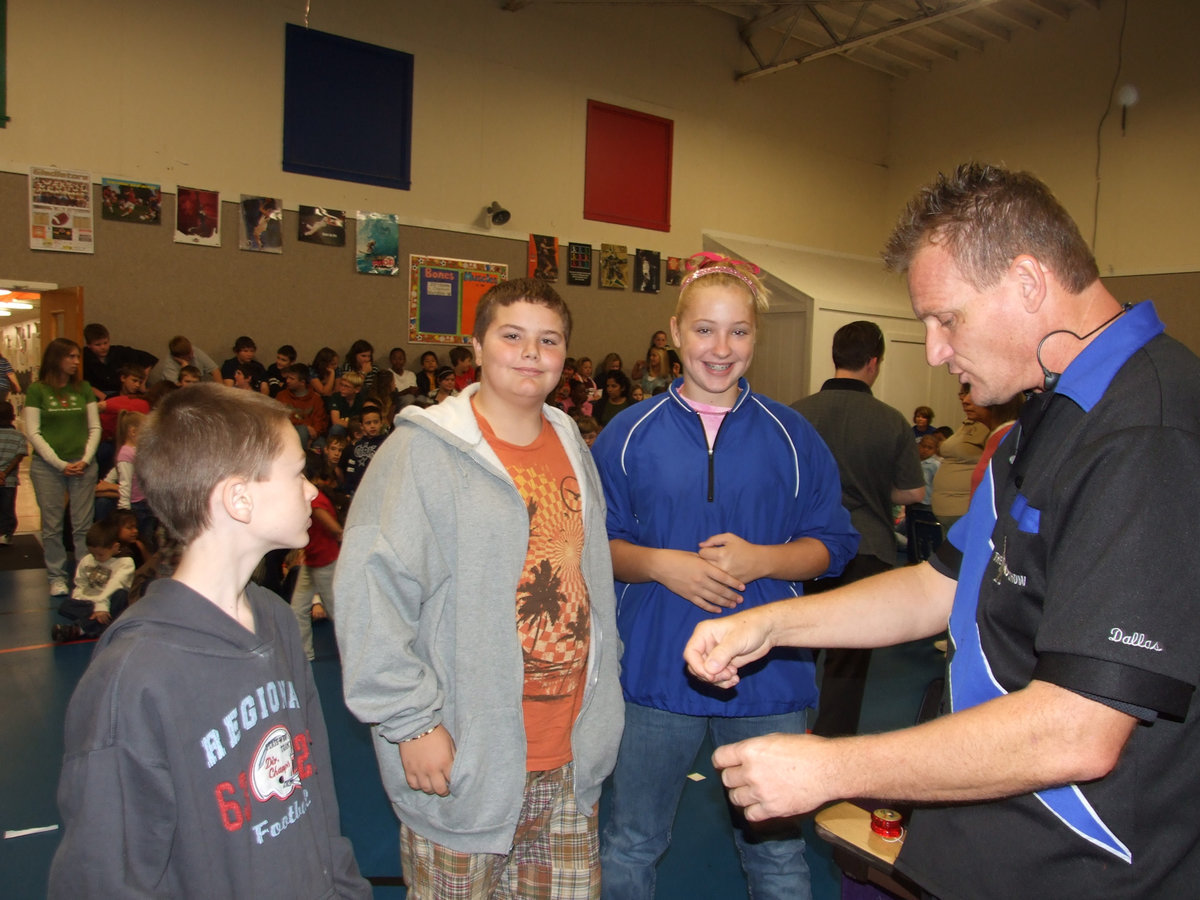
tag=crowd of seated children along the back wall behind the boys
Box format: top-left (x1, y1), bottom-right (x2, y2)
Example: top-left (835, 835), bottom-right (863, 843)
top-left (39, 324), bottom-right (673, 561)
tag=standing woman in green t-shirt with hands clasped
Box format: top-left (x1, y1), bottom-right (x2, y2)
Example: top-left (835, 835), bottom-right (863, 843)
top-left (24, 337), bottom-right (100, 596)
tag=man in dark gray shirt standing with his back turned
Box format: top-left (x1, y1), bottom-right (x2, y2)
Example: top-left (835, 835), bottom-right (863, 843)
top-left (792, 322), bottom-right (925, 737)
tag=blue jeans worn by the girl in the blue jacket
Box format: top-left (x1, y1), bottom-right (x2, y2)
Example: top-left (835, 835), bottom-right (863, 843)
top-left (600, 702), bottom-right (812, 900)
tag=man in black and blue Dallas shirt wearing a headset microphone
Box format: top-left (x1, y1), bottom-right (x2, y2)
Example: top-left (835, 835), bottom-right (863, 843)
top-left (684, 164), bottom-right (1200, 900)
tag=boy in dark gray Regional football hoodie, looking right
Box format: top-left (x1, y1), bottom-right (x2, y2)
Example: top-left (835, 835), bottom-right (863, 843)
top-left (49, 384), bottom-right (371, 900)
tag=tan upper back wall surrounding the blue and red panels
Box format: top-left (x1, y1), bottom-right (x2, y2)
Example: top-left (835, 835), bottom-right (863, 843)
top-left (0, 0), bottom-right (888, 256)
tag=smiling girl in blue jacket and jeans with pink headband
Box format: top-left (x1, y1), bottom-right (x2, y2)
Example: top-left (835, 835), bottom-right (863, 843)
top-left (593, 254), bottom-right (858, 900)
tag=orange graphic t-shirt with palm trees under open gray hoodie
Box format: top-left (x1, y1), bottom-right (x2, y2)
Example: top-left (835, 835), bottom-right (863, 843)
top-left (475, 413), bottom-right (592, 772)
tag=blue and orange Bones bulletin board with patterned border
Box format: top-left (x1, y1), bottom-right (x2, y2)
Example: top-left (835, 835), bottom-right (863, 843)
top-left (408, 253), bottom-right (509, 344)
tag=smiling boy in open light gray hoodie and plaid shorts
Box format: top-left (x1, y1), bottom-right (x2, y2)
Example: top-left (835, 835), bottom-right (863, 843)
top-left (335, 278), bottom-right (623, 900)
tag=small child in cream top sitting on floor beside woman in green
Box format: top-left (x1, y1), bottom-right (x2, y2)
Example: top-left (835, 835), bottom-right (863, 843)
top-left (50, 520), bottom-right (136, 643)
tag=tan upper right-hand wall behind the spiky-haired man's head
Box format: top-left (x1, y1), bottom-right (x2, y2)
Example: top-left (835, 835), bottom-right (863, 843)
top-left (887, 0), bottom-right (1200, 275)
